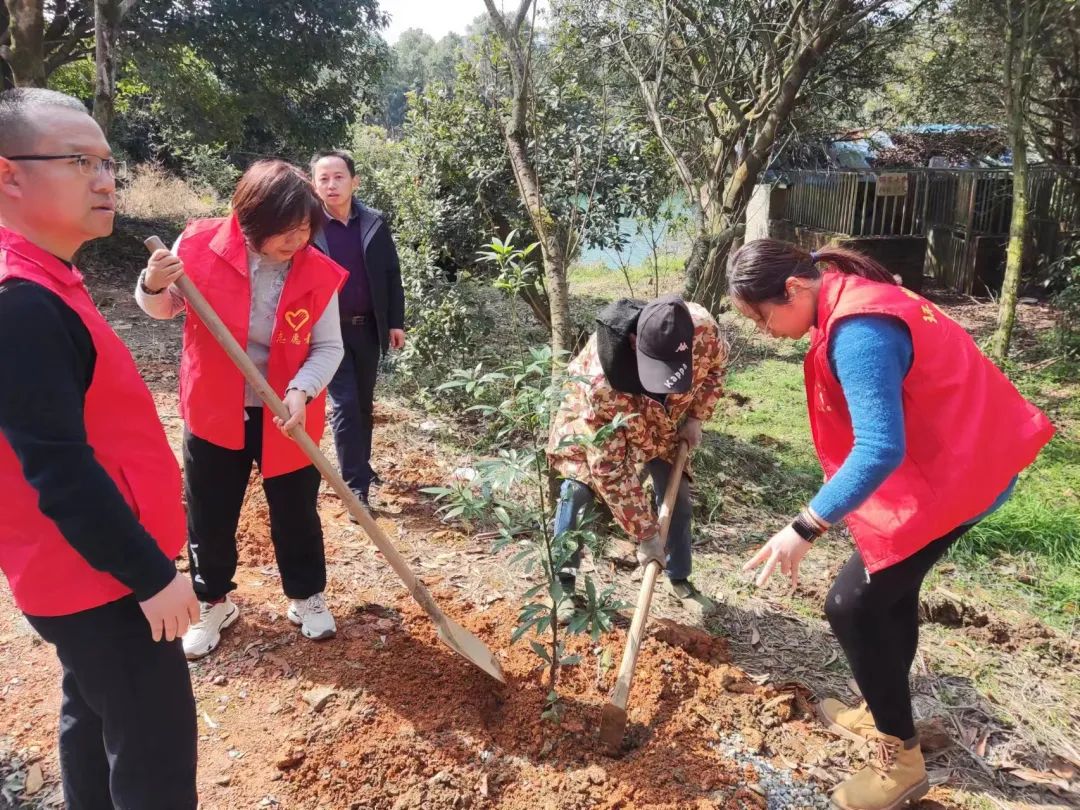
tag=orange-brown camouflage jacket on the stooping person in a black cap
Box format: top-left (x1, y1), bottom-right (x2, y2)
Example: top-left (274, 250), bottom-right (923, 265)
top-left (548, 303), bottom-right (728, 542)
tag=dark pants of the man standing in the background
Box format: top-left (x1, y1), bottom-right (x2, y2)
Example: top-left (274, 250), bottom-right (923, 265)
top-left (326, 315), bottom-right (382, 497)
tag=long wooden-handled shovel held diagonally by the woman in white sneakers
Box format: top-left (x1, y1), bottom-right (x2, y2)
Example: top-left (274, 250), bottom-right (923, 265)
top-left (144, 237), bottom-right (507, 683)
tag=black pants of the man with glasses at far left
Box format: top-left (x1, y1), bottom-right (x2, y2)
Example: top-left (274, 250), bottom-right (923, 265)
top-left (27, 596), bottom-right (199, 810)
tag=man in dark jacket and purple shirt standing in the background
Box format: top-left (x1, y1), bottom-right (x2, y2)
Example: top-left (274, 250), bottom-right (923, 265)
top-left (311, 149), bottom-right (405, 505)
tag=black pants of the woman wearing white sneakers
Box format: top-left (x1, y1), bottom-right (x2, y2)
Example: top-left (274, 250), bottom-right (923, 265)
top-left (184, 408), bottom-right (326, 602)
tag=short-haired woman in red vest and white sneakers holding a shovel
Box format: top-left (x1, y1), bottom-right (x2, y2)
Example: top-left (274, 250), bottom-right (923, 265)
top-left (135, 161), bottom-right (345, 659)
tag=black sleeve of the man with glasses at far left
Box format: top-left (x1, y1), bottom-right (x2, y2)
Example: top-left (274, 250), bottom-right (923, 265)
top-left (0, 281), bottom-right (176, 602)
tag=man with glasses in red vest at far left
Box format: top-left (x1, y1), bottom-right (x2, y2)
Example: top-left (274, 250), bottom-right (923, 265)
top-left (0, 89), bottom-right (199, 810)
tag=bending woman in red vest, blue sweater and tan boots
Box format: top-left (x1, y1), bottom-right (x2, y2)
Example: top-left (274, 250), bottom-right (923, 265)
top-left (729, 240), bottom-right (1053, 810)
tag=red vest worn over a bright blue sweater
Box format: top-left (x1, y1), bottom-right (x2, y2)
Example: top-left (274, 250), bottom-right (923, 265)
top-left (805, 272), bottom-right (1054, 573)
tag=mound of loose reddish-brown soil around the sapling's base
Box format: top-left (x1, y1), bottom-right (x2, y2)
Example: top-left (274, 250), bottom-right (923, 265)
top-left (282, 593), bottom-right (816, 810)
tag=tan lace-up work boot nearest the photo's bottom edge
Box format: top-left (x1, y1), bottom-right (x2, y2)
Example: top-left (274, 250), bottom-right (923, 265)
top-left (832, 733), bottom-right (930, 810)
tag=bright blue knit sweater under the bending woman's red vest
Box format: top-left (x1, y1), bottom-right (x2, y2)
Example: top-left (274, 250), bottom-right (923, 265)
top-left (810, 315), bottom-right (1016, 523)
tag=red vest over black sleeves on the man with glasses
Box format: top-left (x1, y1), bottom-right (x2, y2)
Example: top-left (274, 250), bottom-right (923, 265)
top-left (0, 228), bottom-right (184, 616)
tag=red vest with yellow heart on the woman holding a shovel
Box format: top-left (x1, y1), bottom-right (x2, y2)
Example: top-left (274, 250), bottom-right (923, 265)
top-left (179, 216), bottom-right (346, 478)
